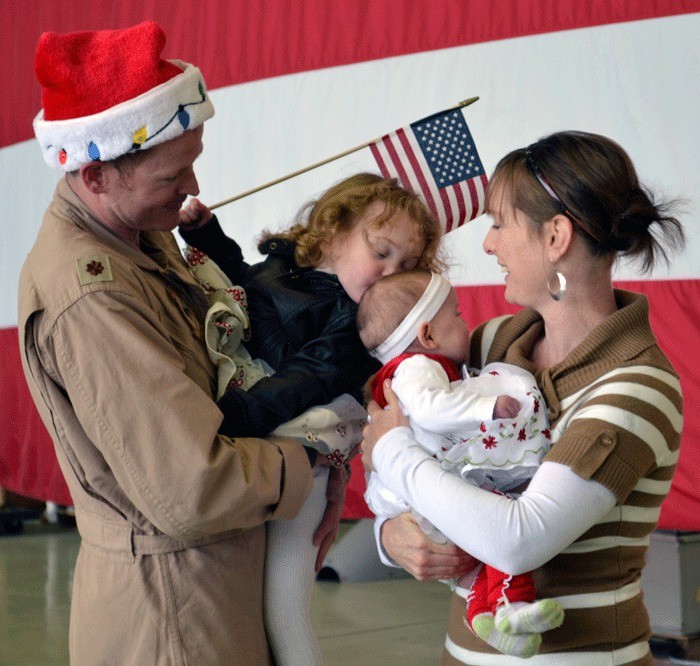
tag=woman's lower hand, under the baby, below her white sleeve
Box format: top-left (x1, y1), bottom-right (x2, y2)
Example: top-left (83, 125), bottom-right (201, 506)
top-left (380, 513), bottom-right (479, 580)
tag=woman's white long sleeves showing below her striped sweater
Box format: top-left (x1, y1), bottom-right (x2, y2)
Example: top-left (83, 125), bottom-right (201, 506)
top-left (372, 427), bottom-right (616, 574)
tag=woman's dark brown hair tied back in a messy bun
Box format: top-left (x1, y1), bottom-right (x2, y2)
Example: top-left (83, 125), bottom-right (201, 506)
top-left (487, 131), bottom-right (685, 273)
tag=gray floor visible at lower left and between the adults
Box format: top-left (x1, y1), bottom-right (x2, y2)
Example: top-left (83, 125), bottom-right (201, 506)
top-left (0, 521), bottom-right (688, 666)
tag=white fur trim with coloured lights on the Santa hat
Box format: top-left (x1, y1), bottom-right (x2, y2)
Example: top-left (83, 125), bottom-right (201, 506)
top-left (34, 60), bottom-right (214, 171)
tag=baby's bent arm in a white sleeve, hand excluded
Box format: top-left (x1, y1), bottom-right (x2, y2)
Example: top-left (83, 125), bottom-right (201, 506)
top-left (391, 355), bottom-right (496, 434)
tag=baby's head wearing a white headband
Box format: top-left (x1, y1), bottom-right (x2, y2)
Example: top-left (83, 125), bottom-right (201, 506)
top-left (357, 270), bottom-right (470, 365)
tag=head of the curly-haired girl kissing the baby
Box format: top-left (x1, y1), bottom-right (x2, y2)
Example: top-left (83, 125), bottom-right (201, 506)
top-left (262, 173), bottom-right (442, 303)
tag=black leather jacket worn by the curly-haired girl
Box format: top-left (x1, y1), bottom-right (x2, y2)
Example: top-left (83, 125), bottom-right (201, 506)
top-left (180, 217), bottom-right (380, 437)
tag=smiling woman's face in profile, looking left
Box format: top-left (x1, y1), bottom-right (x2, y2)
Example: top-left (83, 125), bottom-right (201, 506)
top-left (484, 182), bottom-right (548, 309)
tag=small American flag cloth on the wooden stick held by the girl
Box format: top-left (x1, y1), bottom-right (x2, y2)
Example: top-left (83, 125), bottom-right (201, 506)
top-left (370, 108), bottom-right (488, 233)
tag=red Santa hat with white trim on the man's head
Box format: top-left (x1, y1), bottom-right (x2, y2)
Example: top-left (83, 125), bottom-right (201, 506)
top-left (34, 21), bottom-right (214, 171)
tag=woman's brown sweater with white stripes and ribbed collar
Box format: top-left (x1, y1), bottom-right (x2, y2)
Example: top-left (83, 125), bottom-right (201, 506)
top-left (443, 291), bottom-right (682, 666)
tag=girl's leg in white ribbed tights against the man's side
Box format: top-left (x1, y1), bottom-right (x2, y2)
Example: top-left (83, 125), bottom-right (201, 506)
top-left (265, 468), bottom-right (328, 666)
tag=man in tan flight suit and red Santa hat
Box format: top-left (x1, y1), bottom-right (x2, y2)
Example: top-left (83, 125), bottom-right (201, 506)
top-left (19, 22), bottom-right (343, 665)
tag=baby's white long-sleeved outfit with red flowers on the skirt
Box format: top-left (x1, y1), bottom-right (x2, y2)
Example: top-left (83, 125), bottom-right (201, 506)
top-left (365, 354), bottom-right (550, 540)
